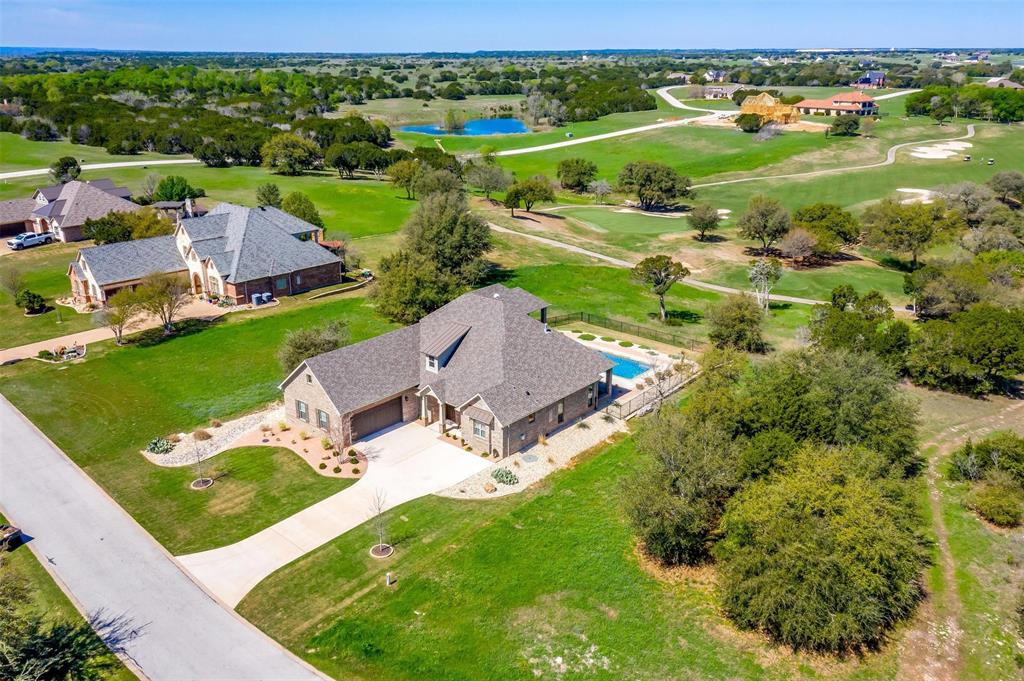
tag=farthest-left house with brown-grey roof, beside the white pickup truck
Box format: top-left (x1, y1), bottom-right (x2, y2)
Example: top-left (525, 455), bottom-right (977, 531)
top-left (29, 179), bottom-right (142, 242)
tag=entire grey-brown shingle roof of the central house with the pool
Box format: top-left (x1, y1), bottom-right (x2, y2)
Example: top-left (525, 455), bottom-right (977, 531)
top-left (306, 285), bottom-right (612, 425)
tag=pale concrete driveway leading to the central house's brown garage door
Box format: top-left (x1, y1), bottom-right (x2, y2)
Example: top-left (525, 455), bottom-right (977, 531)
top-left (178, 423), bottom-right (489, 607)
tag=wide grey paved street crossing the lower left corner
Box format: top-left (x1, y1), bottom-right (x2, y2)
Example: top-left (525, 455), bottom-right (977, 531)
top-left (0, 397), bottom-right (324, 681)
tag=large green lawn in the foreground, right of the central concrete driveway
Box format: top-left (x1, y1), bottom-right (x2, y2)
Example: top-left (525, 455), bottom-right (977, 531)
top-left (239, 440), bottom-right (896, 681)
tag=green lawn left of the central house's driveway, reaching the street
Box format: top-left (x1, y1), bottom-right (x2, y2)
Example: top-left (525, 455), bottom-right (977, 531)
top-left (0, 297), bottom-right (392, 553)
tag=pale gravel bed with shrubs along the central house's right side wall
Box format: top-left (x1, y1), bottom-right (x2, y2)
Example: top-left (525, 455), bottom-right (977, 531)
top-left (436, 412), bottom-right (627, 499)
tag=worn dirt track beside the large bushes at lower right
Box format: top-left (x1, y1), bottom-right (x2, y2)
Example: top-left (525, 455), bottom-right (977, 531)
top-left (896, 401), bottom-right (1024, 681)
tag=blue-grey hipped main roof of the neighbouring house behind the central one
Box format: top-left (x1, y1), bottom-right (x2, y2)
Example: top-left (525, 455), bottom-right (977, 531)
top-left (181, 204), bottom-right (340, 284)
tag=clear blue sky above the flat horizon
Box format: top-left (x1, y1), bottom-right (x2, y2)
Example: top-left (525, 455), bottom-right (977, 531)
top-left (0, 0), bottom-right (1024, 52)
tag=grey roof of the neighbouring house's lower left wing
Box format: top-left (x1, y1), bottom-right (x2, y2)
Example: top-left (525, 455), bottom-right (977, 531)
top-left (78, 236), bottom-right (185, 286)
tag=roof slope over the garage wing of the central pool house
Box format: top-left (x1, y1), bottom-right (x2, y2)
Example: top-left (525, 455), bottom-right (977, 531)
top-left (305, 325), bottom-right (420, 414)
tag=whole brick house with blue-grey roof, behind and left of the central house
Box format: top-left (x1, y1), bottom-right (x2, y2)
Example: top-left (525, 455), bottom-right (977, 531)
top-left (68, 204), bottom-right (344, 304)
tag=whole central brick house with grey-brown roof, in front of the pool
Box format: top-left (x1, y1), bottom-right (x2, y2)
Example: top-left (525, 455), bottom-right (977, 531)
top-left (281, 284), bottom-right (612, 457)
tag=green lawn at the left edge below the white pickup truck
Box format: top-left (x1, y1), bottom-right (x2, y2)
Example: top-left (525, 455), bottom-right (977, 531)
top-left (0, 244), bottom-right (95, 348)
